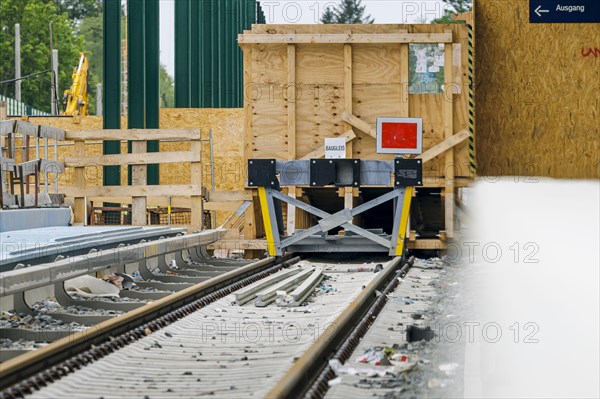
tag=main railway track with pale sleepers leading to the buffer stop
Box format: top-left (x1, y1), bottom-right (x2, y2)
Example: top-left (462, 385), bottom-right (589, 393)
top-left (0, 258), bottom-right (410, 398)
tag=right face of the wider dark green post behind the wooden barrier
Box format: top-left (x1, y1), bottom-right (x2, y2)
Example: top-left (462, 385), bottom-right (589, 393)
top-left (144, 0), bottom-right (159, 185)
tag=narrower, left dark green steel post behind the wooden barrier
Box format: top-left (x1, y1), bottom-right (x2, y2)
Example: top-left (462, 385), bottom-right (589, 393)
top-left (102, 0), bottom-right (121, 206)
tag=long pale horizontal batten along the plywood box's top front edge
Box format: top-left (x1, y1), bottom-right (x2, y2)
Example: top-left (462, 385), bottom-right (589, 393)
top-left (238, 33), bottom-right (452, 44)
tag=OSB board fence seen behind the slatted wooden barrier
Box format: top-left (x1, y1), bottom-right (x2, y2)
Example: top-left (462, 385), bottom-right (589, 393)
top-left (18, 108), bottom-right (245, 191)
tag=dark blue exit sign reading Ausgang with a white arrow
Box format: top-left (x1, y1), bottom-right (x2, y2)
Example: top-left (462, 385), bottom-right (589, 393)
top-left (529, 0), bottom-right (600, 24)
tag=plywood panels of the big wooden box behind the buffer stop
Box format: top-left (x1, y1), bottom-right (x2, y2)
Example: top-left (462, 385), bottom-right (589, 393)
top-left (244, 24), bottom-right (470, 177)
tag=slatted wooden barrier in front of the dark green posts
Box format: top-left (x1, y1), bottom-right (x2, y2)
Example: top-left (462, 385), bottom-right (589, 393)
top-left (61, 129), bottom-right (203, 230)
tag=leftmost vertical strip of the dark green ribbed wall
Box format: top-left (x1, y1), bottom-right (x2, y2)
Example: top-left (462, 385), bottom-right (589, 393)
top-left (175, 0), bottom-right (191, 108)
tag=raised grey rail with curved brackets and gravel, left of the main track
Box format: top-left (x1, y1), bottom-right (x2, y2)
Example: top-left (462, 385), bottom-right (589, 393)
top-left (0, 231), bottom-right (251, 362)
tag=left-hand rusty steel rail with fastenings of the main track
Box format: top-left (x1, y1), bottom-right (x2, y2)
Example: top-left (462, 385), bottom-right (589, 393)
top-left (0, 256), bottom-right (300, 397)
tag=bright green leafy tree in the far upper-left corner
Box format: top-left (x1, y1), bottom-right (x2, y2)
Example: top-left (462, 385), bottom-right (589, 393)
top-left (0, 0), bottom-right (85, 112)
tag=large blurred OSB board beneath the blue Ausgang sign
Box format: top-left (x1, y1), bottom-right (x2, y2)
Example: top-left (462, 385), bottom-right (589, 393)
top-left (475, 0), bottom-right (600, 178)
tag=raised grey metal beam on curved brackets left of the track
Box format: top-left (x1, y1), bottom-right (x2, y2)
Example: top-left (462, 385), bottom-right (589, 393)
top-left (0, 230), bottom-right (225, 296)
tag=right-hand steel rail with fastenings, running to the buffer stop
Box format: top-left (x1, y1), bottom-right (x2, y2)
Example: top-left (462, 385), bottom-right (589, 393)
top-left (266, 257), bottom-right (414, 399)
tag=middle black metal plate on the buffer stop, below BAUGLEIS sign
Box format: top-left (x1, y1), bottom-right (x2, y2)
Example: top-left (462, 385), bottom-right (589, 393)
top-left (310, 159), bottom-right (360, 187)
